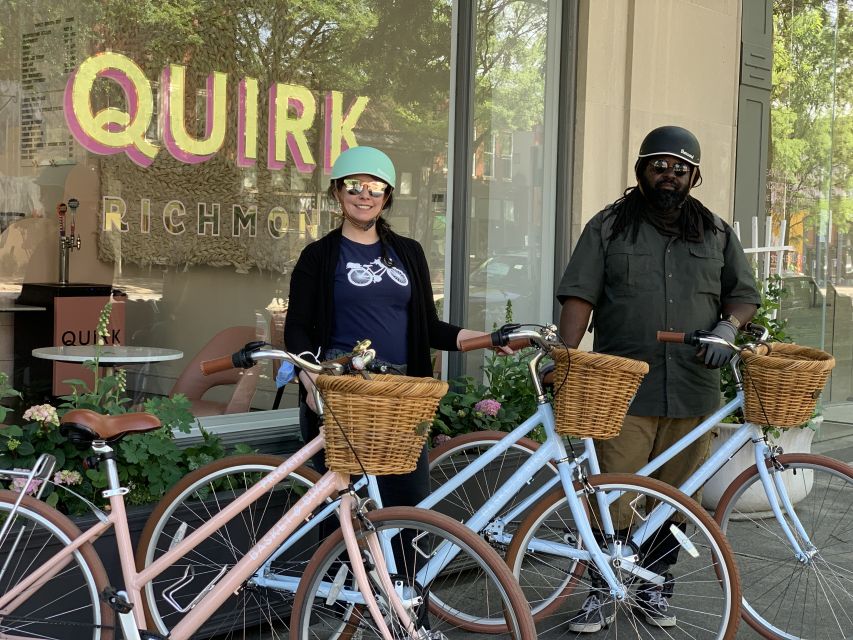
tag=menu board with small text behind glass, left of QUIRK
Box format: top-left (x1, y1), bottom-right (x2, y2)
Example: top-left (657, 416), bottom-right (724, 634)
top-left (20, 17), bottom-right (77, 166)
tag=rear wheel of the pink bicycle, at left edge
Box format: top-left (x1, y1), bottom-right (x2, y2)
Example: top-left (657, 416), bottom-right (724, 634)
top-left (0, 491), bottom-right (115, 640)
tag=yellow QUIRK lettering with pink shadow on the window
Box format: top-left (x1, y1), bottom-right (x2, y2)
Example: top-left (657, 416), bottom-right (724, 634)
top-left (64, 51), bottom-right (369, 173)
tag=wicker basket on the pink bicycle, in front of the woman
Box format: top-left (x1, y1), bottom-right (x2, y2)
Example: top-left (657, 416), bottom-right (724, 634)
top-left (317, 375), bottom-right (447, 475)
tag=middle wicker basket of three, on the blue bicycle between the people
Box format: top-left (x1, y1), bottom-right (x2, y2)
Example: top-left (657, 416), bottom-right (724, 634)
top-left (551, 349), bottom-right (649, 440)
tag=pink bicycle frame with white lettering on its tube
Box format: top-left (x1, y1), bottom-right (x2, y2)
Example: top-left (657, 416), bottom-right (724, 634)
top-left (0, 437), bottom-right (414, 640)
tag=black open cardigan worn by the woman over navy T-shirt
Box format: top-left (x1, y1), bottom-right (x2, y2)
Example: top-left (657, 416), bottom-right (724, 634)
top-left (284, 228), bottom-right (460, 376)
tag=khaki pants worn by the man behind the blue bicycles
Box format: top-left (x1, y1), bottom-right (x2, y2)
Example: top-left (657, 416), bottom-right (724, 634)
top-left (595, 416), bottom-right (713, 530)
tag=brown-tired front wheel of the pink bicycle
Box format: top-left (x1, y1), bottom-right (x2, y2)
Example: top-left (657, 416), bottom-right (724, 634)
top-left (291, 507), bottom-right (536, 640)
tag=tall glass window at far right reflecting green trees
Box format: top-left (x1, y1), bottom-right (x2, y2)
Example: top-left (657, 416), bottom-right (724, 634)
top-left (768, 0), bottom-right (853, 422)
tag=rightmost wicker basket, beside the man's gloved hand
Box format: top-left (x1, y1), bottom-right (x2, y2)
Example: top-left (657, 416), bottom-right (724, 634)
top-left (741, 342), bottom-right (835, 428)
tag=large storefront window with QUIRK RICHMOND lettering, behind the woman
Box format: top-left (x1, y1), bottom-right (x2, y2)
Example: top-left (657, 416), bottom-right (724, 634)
top-left (0, 0), bottom-right (452, 406)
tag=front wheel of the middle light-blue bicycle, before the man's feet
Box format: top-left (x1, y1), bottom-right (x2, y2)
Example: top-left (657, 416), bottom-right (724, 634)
top-left (507, 473), bottom-right (740, 640)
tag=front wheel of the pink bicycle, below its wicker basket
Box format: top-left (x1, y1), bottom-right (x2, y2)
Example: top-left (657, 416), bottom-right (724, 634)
top-left (291, 507), bottom-right (536, 640)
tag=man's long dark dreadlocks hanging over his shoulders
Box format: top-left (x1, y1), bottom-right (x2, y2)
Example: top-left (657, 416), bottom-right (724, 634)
top-left (605, 186), bottom-right (723, 242)
